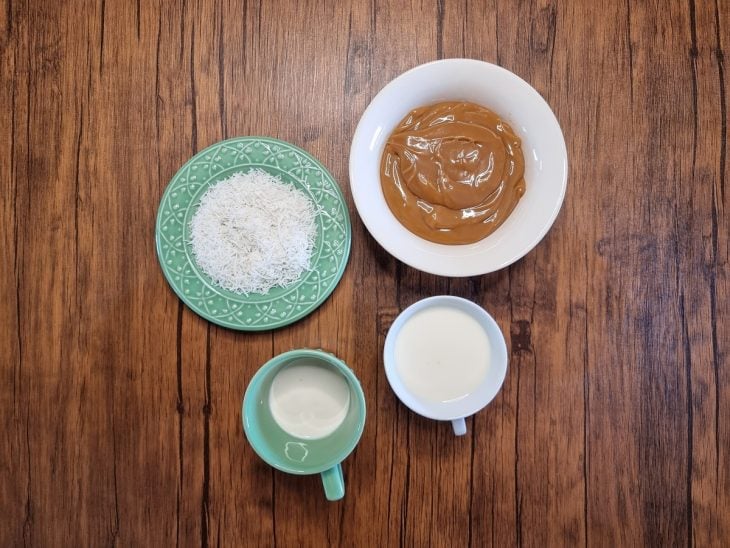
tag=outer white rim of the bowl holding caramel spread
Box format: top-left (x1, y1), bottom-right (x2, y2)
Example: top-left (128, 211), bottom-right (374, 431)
top-left (348, 58), bottom-right (569, 277)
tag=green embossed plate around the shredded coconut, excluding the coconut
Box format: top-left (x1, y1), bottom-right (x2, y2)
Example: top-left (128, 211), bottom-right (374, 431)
top-left (155, 137), bottom-right (352, 331)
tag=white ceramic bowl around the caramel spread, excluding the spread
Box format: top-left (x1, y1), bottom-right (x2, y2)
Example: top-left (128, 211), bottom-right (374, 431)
top-left (350, 59), bottom-right (568, 276)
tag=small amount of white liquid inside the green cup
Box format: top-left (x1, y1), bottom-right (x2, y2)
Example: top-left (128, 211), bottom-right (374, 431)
top-left (269, 362), bottom-right (350, 439)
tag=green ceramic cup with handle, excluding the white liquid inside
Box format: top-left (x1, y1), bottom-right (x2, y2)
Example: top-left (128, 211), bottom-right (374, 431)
top-left (241, 349), bottom-right (365, 500)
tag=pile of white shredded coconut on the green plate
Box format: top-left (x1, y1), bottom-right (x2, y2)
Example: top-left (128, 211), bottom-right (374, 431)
top-left (190, 169), bottom-right (317, 295)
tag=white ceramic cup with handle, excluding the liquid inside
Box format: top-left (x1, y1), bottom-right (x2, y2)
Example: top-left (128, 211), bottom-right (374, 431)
top-left (383, 295), bottom-right (508, 436)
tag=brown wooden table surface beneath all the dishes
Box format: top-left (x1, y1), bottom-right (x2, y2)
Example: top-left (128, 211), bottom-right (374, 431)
top-left (0, 0), bottom-right (730, 547)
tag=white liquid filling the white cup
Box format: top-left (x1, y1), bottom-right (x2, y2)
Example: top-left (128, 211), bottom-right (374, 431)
top-left (395, 306), bottom-right (490, 402)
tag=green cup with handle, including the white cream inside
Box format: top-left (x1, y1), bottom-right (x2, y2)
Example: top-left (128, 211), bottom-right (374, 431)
top-left (241, 349), bottom-right (365, 500)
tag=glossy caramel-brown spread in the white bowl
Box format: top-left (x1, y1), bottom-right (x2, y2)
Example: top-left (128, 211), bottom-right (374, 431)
top-left (380, 101), bottom-right (525, 244)
